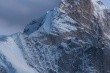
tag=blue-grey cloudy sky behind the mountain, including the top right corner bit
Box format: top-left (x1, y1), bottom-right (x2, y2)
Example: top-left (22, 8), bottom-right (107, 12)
top-left (0, 0), bottom-right (110, 35)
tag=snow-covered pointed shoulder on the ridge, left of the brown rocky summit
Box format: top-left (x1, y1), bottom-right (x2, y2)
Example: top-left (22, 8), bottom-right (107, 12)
top-left (31, 7), bottom-right (77, 37)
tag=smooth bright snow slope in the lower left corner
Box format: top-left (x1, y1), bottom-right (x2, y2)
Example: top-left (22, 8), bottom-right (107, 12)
top-left (0, 37), bottom-right (37, 73)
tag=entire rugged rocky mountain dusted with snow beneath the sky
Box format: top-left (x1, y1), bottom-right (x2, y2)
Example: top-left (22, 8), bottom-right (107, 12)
top-left (0, 0), bottom-right (110, 73)
